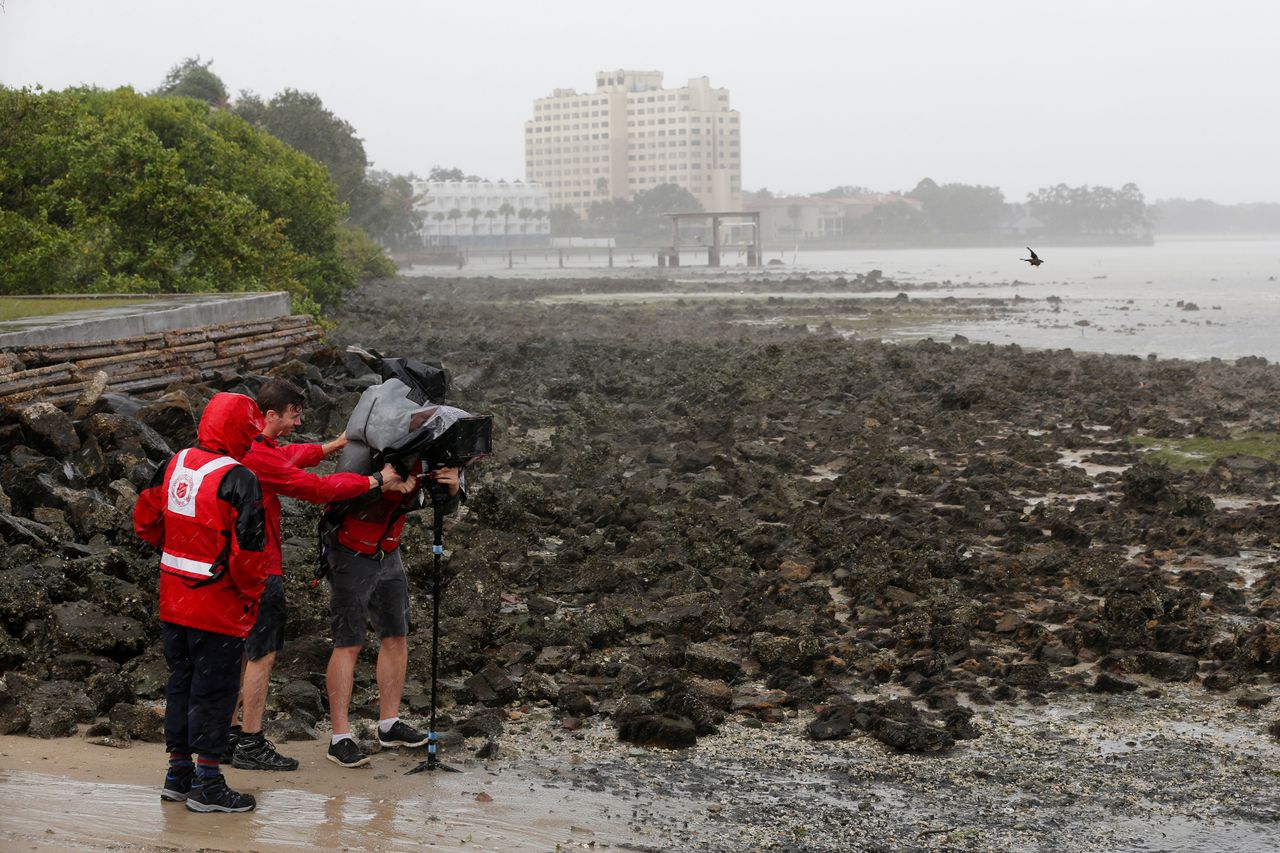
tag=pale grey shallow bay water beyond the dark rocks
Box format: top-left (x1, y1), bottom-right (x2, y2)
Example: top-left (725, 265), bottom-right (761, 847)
top-left (417, 238), bottom-right (1280, 360)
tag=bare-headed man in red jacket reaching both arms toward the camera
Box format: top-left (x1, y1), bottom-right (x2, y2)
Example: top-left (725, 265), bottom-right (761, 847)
top-left (232, 379), bottom-right (403, 771)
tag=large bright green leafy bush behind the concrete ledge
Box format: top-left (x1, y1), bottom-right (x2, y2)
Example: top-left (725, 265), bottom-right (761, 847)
top-left (0, 88), bottom-right (357, 313)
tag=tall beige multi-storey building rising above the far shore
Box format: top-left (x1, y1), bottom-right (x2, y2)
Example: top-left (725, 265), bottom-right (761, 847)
top-left (525, 70), bottom-right (742, 214)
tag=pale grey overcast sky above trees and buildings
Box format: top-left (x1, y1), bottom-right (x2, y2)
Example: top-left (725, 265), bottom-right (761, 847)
top-left (0, 0), bottom-right (1280, 202)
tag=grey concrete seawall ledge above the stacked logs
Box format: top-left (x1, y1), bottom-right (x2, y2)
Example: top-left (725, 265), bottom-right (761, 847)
top-left (0, 291), bottom-right (289, 350)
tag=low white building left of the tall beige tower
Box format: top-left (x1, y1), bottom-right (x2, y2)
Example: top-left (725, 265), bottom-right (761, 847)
top-left (413, 181), bottom-right (552, 248)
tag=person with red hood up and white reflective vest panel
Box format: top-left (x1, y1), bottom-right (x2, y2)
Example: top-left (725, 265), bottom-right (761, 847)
top-left (133, 393), bottom-right (266, 812)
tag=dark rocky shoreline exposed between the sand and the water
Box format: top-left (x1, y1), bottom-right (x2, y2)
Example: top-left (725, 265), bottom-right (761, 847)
top-left (0, 277), bottom-right (1280, 850)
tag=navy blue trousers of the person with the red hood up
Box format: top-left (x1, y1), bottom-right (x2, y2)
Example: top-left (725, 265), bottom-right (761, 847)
top-left (161, 622), bottom-right (244, 756)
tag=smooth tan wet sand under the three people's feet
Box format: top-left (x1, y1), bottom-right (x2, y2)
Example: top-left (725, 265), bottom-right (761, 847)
top-left (0, 736), bottom-right (660, 853)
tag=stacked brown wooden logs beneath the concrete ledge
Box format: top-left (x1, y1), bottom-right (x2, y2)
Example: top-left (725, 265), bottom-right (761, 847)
top-left (0, 315), bottom-right (323, 405)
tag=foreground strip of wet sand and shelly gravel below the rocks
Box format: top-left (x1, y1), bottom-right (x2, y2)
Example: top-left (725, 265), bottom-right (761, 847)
top-left (0, 676), bottom-right (1280, 853)
